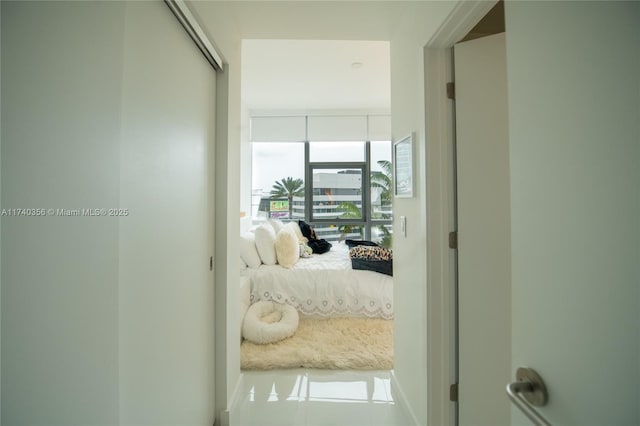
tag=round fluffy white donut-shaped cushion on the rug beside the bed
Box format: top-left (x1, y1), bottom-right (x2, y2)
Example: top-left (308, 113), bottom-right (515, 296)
top-left (242, 300), bottom-right (299, 345)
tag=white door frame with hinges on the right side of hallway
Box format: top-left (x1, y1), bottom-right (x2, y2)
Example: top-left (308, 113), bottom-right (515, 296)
top-left (424, 0), bottom-right (497, 426)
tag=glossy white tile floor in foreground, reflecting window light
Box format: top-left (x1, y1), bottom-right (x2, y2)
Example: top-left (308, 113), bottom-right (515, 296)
top-left (230, 369), bottom-right (412, 426)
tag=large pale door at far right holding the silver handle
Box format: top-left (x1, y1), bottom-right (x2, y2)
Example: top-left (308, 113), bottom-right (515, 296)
top-left (505, 2), bottom-right (640, 425)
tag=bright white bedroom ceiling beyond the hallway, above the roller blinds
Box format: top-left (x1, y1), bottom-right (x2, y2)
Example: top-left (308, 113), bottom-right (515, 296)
top-left (241, 40), bottom-right (391, 112)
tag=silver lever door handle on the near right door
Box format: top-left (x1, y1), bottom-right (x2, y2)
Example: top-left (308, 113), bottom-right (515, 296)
top-left (507, 368), bottom-right (551, 426)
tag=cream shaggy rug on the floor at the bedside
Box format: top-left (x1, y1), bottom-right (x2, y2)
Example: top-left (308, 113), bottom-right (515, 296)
top-left (240, 318), bottom-right (393, 370)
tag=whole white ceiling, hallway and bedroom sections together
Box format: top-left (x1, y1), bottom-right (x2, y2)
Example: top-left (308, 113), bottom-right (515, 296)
top-left (192, 0), bottom-right (457, 112)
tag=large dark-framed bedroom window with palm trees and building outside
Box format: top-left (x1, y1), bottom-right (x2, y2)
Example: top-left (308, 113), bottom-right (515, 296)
top-left (252, 135), bottom-right (393, 246)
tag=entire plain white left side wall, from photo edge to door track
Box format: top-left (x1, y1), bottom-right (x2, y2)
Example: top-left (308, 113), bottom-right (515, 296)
top-left (1, 1), bottom-right (220, 425)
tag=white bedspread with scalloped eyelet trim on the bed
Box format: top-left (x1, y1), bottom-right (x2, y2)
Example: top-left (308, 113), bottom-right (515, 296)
top-left (245, 243), bottom-right (393, 319)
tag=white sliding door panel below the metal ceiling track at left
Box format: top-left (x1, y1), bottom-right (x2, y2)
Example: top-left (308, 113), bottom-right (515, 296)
top-left (119, 2), bottom-right (216, 425)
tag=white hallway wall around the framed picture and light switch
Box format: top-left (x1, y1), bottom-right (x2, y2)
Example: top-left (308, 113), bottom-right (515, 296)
top-left (391, 2), bottom-right (455, 424)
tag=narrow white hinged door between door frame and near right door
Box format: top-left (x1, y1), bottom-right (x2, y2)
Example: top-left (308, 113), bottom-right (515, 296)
top-left (454, 33), bottom-right (511, 426)
